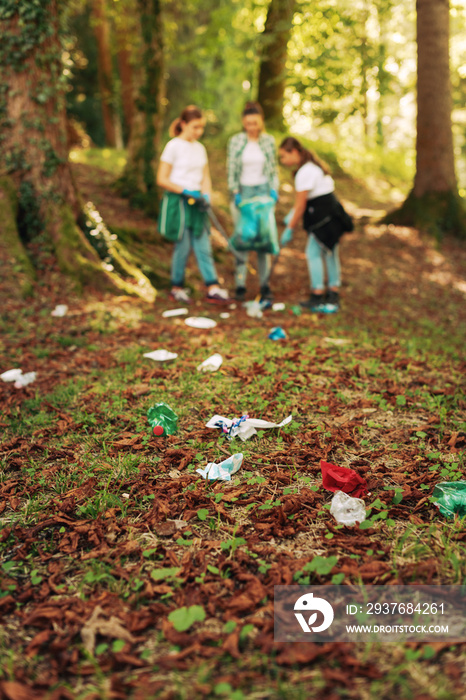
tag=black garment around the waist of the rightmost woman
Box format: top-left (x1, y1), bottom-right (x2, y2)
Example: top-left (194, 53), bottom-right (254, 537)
top-left (303, 192), bottom-right (354, 250)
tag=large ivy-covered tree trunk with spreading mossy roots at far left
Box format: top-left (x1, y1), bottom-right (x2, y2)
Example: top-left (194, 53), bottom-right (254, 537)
top-left (0, 0), bottom-right (154, 298)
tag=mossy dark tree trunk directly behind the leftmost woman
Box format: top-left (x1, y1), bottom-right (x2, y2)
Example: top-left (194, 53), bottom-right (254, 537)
top-left (118, 0), bottom-right (164, 217)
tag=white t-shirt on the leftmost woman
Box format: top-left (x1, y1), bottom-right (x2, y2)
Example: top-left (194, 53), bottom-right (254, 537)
top-left (160, 136), bottom-right (207, 190)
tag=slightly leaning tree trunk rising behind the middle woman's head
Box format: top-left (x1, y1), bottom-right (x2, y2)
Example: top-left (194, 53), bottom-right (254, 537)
top-left (257, 0), bottom-right (296, 129)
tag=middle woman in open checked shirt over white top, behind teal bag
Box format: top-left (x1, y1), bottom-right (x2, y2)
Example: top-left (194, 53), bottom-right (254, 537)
top-left (227, 102), bottom-right (279, 301)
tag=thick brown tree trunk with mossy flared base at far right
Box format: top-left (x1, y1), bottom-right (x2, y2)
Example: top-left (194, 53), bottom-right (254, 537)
top-left (387, 0), bottom-right (466, 238)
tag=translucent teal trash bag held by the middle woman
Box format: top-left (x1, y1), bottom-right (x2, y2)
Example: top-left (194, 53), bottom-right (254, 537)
top-left (231, 196), bottom-right (280, 255)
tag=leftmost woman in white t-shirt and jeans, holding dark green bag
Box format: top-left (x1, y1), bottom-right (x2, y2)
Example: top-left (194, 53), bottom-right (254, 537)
top-left (157, 105), bottom-right (230, 304)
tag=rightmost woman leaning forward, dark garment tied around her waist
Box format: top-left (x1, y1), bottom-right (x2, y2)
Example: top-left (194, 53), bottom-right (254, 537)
top-left (278, 136), bottom-right (341, 313)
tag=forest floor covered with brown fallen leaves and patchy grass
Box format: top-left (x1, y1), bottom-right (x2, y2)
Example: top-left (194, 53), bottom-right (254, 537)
top-left (0, 145), bottom-right (466, 700)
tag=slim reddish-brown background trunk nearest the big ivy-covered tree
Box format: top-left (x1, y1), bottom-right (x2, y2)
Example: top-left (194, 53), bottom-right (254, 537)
top-left (92, 0), bottom-right (117, 148)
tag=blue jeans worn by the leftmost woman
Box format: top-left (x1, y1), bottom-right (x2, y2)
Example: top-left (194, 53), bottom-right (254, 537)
top-left (171, 228), bottom-right (217, 287)
